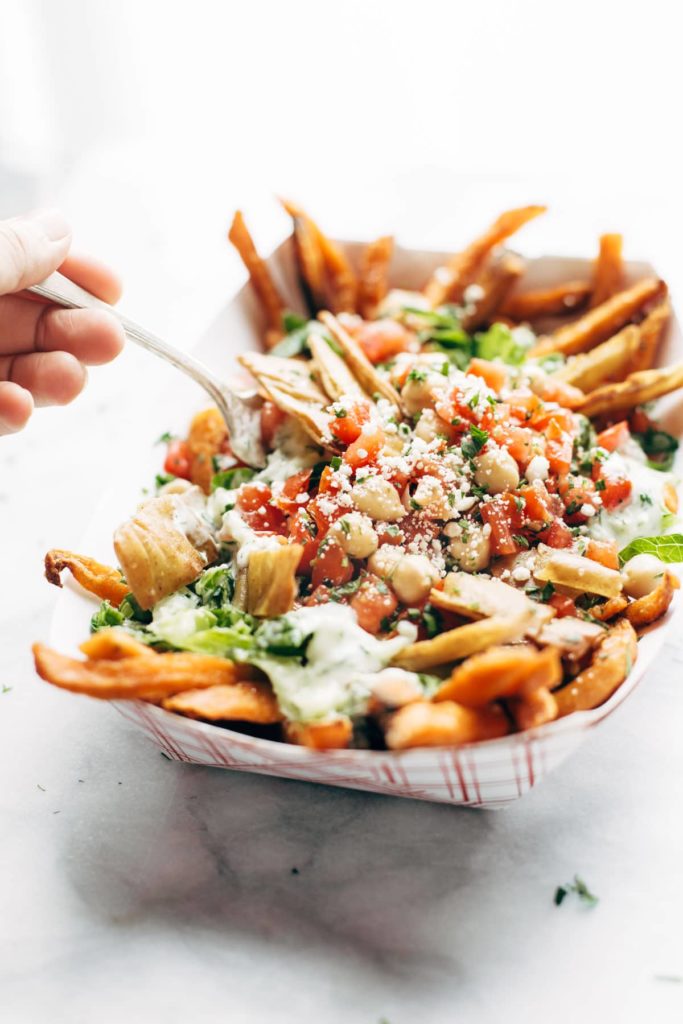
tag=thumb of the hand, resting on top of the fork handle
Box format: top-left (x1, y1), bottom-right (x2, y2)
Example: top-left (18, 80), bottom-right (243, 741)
top-left (0, 210), bottom-right (71, 295)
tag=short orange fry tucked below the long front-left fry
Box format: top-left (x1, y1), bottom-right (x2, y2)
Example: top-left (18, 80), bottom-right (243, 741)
top-left (162, 679), bottom-right (283, 725)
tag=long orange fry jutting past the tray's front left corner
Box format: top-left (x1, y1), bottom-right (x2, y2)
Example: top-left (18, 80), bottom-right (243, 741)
top-left (33, 643), bottom-right (250, 702)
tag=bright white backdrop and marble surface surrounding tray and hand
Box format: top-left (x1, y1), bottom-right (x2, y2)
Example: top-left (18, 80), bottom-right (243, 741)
top-left (0, 0), bottom-right (683, 1024)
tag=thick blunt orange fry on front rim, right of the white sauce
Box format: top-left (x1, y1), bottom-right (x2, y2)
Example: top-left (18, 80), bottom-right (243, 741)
top-left (384, 700), bottom-right (510, 751)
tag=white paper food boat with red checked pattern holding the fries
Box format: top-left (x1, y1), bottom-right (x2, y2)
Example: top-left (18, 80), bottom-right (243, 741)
top-left (51, 241), bottom-right (683, 809)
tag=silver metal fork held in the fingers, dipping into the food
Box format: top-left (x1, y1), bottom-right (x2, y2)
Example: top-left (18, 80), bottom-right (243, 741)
top-left (27, 271), bottom-right (265, 468)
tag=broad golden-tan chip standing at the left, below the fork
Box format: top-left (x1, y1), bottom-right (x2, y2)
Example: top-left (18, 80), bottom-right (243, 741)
top-left (114, 492), bottom-right (216, 608)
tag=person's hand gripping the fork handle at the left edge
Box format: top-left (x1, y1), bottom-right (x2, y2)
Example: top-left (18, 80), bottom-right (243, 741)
top-left (0, 210), bottom-right (124, 434)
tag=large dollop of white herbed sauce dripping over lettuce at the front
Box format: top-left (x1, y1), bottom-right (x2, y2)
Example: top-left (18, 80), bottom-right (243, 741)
top-left (249, 603), bottom-right (417, 722)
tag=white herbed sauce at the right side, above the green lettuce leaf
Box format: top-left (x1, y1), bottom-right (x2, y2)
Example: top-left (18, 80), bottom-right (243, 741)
top-left (588, 449), bottom-right (675, 548)
